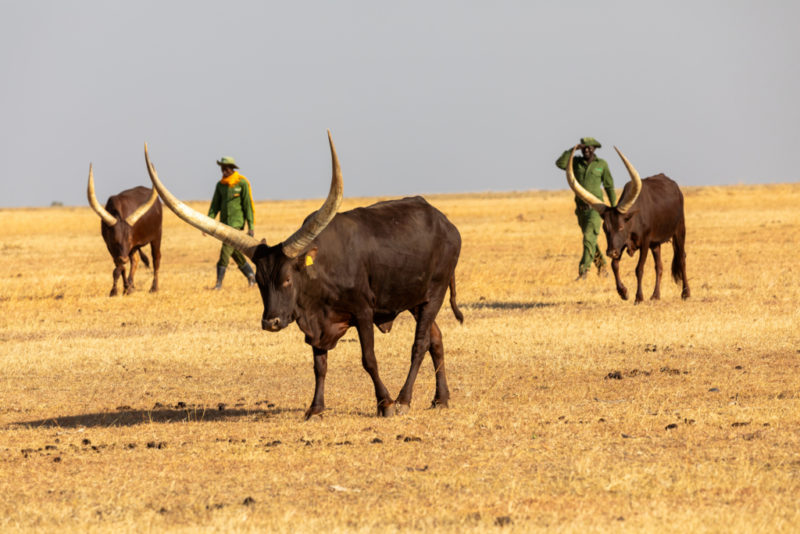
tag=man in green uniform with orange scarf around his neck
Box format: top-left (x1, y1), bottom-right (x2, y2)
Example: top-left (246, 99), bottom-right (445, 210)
top-left (204, 156), bottom-right (256, 289)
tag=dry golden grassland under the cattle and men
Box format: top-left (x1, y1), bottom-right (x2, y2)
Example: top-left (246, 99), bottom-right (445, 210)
top-left (0, 183), bottom-right (800, 533)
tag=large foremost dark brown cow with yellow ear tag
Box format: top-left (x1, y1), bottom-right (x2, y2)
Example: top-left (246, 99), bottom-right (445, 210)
top-left (145, 131), bottom-right (464, 419)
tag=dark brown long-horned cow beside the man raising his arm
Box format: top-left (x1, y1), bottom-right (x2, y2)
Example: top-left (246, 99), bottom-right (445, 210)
top-left (567, 147), bottom-right (690, 304)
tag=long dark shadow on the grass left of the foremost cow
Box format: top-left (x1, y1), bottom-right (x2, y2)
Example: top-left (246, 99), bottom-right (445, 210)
top-left (8, 407), bottom-right (303, 428)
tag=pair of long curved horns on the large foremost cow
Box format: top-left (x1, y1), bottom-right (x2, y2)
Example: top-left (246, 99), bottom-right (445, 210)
top-left (144, 130), bottom-right (343, 259)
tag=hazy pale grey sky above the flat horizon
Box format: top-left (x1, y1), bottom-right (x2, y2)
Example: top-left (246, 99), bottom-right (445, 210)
top-left (0, 0), bottom-right (800, 207)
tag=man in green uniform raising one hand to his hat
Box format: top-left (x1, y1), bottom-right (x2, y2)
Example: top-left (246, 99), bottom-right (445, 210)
top-left (556, 137), bottom-right (617, 280)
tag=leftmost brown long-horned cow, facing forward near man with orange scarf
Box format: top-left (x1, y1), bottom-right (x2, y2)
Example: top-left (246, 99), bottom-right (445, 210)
top-left (87, 165), bottom-right (161, 297)
